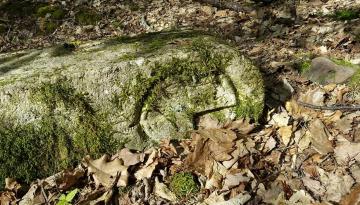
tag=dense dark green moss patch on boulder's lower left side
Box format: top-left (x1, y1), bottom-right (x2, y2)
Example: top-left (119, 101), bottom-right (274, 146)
top-left (0, 80), bottom-right (119, 187)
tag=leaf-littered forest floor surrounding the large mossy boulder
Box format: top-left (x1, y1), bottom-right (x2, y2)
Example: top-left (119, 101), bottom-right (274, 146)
top-left (0, 0), bottom-right (360, 205)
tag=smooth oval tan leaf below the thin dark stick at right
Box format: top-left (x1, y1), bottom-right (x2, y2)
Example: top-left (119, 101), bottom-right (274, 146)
top-left (309, 119), bottom-right (333, 155)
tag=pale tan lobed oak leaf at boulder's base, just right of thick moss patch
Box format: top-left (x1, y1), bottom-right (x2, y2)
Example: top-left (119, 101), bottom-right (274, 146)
top-left (84, 155), bottom-right (129, 188)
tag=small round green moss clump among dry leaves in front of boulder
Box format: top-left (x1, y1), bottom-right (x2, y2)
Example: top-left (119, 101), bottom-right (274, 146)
top-left (170, 172), bottom-right (200, 198)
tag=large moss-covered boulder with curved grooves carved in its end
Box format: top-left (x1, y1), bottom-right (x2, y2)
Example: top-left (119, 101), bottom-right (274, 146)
top-left (0, 31), bottom-right (264, 184)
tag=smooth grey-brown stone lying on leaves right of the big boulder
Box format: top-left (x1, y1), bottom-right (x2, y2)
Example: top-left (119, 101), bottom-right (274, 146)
top-left (305, 57), bottom-right (355, 84)
